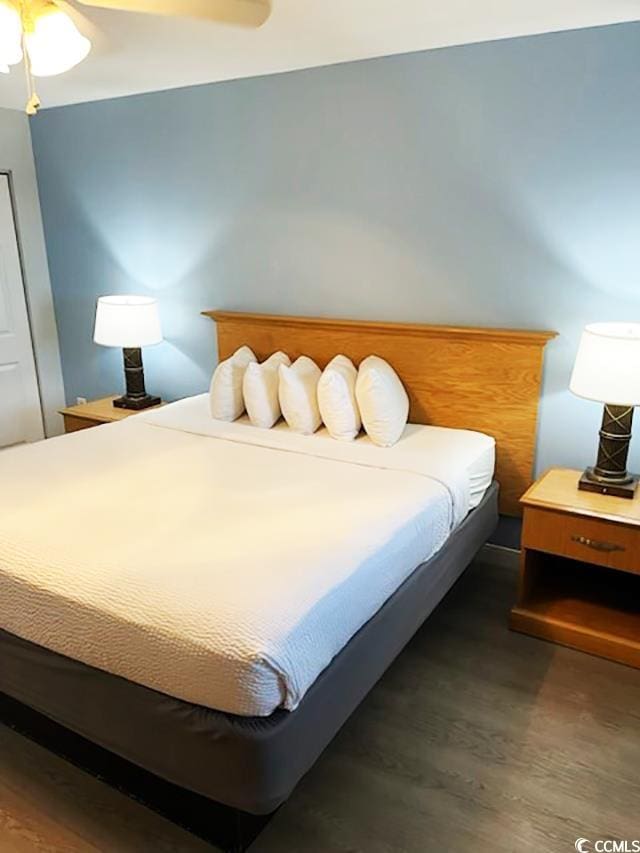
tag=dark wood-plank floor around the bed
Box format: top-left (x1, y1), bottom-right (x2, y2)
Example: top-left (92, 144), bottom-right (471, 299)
top-left (0, 562), bottom-right (640, 853)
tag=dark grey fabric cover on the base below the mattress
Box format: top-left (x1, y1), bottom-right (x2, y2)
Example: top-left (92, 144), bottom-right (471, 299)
top-left (0, 483), bottom-right (498, 814)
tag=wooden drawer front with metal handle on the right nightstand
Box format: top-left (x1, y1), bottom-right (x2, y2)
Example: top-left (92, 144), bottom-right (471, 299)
top-left (522, 507), bottom-right (640, 574)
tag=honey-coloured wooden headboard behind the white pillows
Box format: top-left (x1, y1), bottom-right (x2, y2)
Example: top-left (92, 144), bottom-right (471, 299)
top-left (203, 311), bottom-right (555, 515)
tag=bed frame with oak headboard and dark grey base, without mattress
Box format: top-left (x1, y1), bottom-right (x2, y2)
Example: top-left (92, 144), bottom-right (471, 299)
top-left (0, 312), bottom-right (552, 851)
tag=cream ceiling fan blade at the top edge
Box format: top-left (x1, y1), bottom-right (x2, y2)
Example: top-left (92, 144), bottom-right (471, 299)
top-left (79, 0), bottom-right (271, 27)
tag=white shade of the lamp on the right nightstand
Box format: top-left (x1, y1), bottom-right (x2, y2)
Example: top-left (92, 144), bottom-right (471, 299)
top-left (569, 323), bottom-right (640, 406)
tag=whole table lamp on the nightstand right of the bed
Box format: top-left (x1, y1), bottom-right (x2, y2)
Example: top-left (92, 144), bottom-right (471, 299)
top-left (569, 323), bottom-right (640, 498)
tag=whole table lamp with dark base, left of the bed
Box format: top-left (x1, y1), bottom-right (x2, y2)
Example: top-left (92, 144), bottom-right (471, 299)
top-left (93, 296), bottom-right (162, 409)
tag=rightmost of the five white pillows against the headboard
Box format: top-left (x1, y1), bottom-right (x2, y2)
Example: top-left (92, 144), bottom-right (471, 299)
top-left (356, 355), bottom-right (409, 447)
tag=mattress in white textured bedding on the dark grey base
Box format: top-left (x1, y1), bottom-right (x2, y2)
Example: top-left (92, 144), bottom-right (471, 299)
top-left (0, 395), bottom-right (492, 716)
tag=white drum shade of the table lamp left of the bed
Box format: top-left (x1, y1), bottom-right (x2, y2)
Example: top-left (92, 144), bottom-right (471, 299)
top-left (93, 296), bottom-right (162, 348)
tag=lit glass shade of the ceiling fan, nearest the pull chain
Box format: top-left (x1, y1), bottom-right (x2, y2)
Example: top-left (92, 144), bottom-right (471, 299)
top-left (25, 3), bottom-right (91, 77)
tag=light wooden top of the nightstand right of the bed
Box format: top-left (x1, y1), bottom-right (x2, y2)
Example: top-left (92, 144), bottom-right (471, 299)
top-left (521, 468), bottom-right (640, 527)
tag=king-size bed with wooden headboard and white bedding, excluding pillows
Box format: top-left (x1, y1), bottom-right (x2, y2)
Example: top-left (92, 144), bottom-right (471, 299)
top-left (0, 312), bottom-right (550, 844)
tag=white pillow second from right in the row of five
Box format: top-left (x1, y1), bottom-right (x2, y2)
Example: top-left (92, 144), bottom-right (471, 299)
top-left (318, 355), bottom-right (361, 441)
